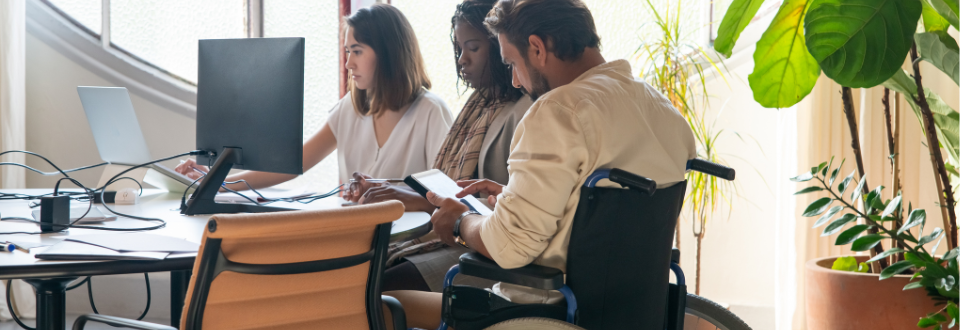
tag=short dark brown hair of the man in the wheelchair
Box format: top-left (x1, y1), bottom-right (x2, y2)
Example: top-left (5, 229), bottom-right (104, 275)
top-left (484, 0), bottom-right (600, 61)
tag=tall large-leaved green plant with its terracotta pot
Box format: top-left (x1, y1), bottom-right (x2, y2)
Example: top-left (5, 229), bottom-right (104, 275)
top-left (714, 0), bottom-right (960, 329)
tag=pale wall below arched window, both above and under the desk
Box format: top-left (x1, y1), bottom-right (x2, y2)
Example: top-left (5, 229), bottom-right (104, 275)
top-left (26, 29), bottom-right (195, 322)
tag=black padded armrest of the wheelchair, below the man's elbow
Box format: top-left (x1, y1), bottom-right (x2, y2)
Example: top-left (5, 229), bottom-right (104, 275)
top-left (460, 252), bottom-right (563, 290)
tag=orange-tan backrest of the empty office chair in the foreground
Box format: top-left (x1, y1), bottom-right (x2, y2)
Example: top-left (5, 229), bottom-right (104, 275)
top-left (180, 201), bottom-right (403, 329)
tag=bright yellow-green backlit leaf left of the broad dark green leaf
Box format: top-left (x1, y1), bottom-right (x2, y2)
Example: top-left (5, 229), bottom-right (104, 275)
top-left (747, 0), bottom-right (820, 108)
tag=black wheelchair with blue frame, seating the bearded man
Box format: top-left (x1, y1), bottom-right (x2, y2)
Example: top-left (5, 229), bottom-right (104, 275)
top-left (432, 159), bottom-right (750, 330)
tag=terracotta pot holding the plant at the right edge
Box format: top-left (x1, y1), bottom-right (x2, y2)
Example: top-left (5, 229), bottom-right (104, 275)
top-left (806, 256), bottom-right (943, 330)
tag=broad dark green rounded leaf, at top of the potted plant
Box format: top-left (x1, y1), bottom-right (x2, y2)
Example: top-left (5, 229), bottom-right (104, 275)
top-left (804, 0), bottom-right (923, 87)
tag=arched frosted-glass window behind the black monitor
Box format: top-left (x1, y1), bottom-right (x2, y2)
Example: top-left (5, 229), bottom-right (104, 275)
top-left (43, 0), bottom-right (341, 192)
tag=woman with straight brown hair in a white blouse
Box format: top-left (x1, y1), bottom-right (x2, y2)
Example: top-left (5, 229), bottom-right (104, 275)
top-left (176, 4), bottom-right (453, 190)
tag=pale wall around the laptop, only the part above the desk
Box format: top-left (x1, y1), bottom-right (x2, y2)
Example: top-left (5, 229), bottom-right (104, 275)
top-left (26, 34), bottom-right (196, 188)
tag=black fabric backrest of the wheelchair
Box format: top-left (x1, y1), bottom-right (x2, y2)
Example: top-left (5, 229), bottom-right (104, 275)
top-left (566, 181), bottom-right (686, 329)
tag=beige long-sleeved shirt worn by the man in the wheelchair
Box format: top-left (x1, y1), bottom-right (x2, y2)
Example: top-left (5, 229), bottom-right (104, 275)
top-left (480, 60), bottom-right (696, 302)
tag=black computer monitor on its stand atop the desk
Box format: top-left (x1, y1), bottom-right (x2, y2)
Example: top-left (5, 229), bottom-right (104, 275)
top-left (181, 38), bottom-right (304, 215)
